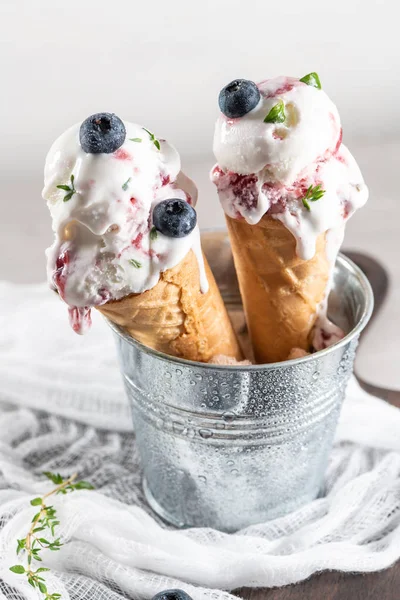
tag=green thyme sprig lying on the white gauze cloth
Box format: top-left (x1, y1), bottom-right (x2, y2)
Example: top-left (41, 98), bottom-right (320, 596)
top-left (9, 471), bottom-right (93, 600)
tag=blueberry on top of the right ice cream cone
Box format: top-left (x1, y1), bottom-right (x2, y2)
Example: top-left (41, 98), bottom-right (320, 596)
top-left (218, 79), bottom-right (261, 119)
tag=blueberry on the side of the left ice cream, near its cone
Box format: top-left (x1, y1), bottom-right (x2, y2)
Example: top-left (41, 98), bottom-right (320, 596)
top-left (153, 198), bottom-right (197, 237)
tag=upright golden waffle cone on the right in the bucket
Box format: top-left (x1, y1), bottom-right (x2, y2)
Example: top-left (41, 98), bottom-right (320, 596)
top-left (226, 216), bottom-right (330, 364)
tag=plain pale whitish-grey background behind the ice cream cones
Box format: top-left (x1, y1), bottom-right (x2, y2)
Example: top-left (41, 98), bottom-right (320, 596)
top-left (0, 0), bottom-right (400, 387)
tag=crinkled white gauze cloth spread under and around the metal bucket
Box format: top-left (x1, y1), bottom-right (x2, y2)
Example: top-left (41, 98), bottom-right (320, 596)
top-left (0, 283), bottom-right (400, 600)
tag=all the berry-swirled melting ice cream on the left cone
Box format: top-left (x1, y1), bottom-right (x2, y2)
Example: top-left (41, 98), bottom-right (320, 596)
top-left (43, 122), bottom-right (208, 333)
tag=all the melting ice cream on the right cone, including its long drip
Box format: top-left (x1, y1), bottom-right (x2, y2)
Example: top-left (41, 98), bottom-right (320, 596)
top-left (211, 77), bottom-right (368, 349)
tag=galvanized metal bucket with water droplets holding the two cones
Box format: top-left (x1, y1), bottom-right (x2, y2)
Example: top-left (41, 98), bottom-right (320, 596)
top-left (110, 234), bottom-right (373, 531)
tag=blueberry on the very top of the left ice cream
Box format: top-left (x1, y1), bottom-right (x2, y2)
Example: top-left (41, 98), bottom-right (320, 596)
top-left (79, 113), bottom-right (126, 154)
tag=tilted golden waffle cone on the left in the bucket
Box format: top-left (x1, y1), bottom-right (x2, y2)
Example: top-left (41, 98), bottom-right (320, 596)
top-left (98, 251), bottom-right (243, 362)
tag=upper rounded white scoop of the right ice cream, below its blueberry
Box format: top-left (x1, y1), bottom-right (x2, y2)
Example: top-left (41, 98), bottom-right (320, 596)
top-left (214, 77), bottom-right (341, 184)
